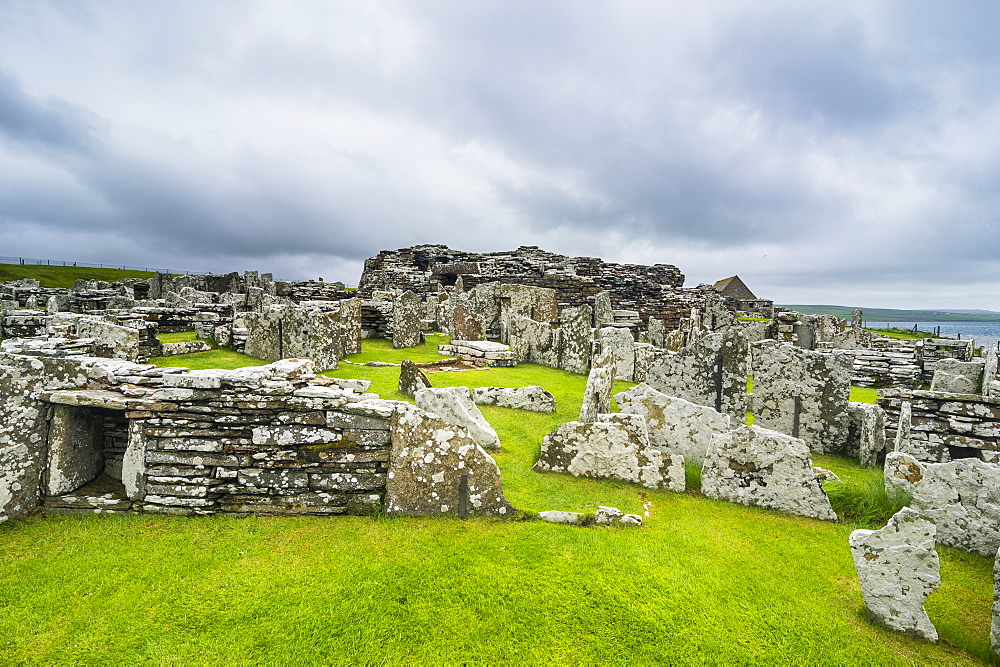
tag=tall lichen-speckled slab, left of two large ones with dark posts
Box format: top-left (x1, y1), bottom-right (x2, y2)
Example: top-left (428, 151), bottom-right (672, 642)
top-left (646, 330), bottom-right (749, 424)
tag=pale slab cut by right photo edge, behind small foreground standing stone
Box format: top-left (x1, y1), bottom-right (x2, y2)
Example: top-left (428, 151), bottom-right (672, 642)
top-left (885, 452), bottom-right (1000, 557)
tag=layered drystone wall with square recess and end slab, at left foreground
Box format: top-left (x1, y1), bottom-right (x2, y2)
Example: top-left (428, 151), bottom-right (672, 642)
top-left (0, 354), bottom-right (512, 521)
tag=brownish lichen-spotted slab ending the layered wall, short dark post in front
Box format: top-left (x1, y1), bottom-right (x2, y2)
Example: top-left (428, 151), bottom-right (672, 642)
top-left (385, 407), bottom-right (513, 517)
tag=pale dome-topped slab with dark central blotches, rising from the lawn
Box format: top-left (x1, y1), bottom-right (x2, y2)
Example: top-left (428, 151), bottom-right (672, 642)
top-left (701, 425), bottom-right (837, 521)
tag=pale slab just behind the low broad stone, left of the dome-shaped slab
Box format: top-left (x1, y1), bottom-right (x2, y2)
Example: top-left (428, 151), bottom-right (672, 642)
top-left (615, 384), bottom-right (730, 463)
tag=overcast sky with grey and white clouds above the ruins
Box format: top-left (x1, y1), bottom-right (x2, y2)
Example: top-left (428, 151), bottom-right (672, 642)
top-left (0, 0), bottom-right (1000, 310)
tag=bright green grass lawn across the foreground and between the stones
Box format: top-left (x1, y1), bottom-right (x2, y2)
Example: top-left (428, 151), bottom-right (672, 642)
top-left (0, 340), bottom-right (993, 664)
